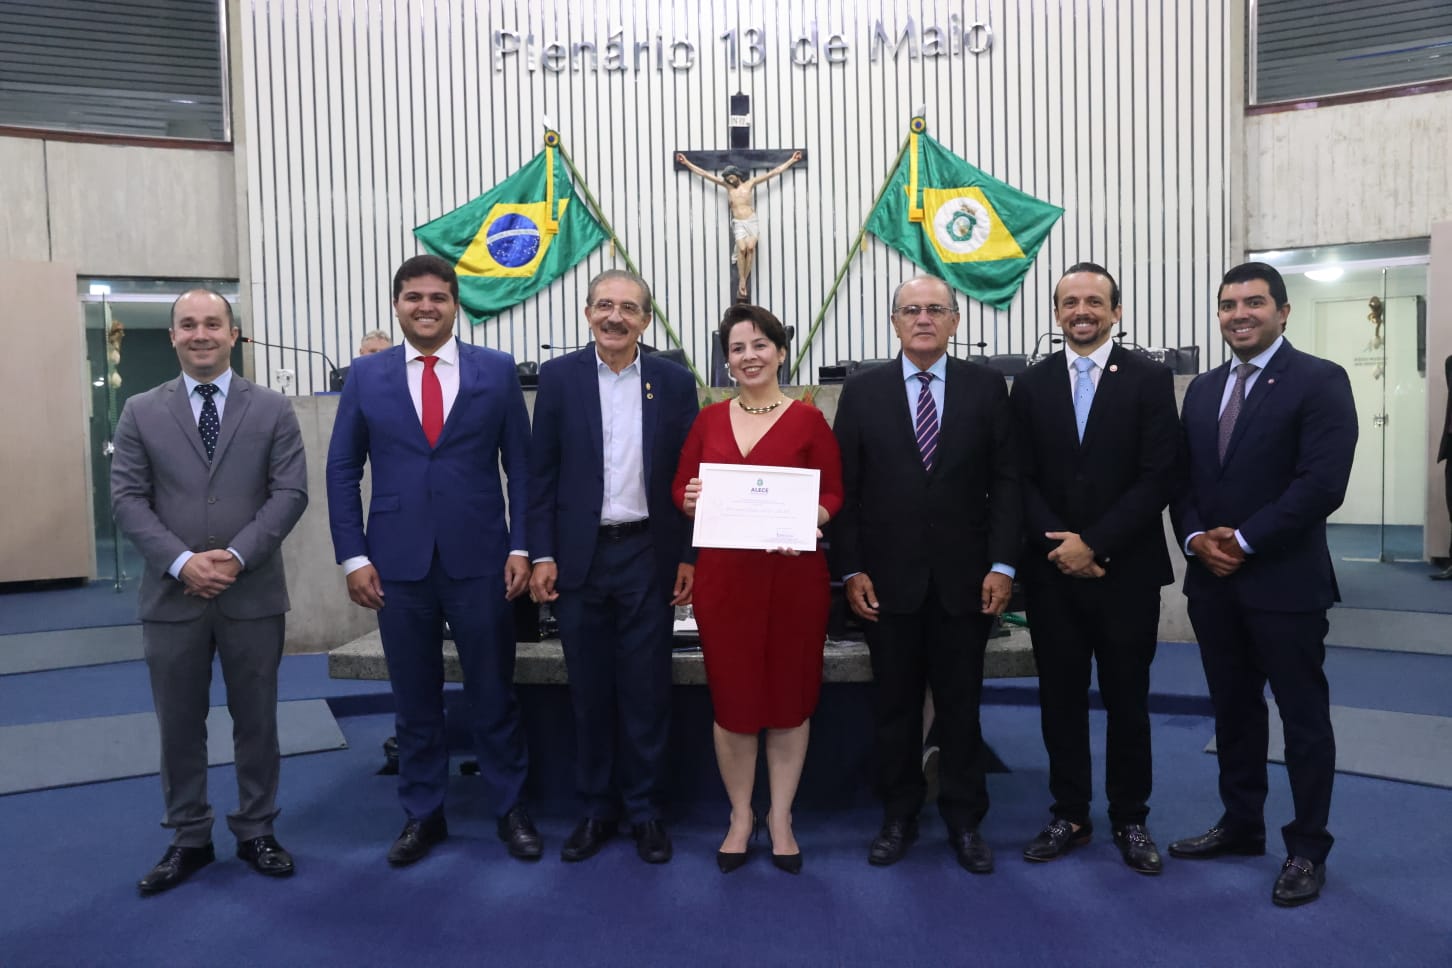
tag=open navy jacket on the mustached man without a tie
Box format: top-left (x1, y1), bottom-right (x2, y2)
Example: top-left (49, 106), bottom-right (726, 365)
top-left (529, 343), bottom-right (698, 591)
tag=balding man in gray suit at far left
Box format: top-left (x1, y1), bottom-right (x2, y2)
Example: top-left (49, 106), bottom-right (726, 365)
top-left (110, 289), bottom-right (308, 894)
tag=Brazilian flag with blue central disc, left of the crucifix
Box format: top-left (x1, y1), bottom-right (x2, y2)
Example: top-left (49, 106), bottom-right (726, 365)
top-left (414, 131), bottom-right (605, 324)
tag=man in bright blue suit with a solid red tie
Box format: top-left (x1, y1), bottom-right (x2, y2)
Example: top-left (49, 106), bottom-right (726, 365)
top-left (328, 255), bottom-right (542, 866)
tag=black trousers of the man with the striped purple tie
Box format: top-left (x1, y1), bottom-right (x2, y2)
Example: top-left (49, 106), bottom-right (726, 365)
top-left (867, 588), bottom-right (990, 830)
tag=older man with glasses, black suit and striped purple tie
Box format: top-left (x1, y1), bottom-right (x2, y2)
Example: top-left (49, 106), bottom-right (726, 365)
top-left (832, 276), bottom-right (1022, 874)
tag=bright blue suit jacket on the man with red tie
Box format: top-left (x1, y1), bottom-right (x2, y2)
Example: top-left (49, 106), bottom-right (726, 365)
top-left (328, 343), bottom-right (530, 582)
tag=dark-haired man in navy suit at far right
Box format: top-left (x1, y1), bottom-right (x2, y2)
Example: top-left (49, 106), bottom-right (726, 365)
top-left (1170, 263), bottom-right (1356, 907)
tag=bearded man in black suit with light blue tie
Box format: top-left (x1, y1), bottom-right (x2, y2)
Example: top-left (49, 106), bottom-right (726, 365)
top-left (1011, 263), bottom-right (1179, 874)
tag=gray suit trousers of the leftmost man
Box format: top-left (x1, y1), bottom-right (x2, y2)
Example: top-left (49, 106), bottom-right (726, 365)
top-left (141, 612), bottom-right (283, 848)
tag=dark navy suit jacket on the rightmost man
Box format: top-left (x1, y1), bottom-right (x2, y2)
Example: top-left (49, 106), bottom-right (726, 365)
top-left (1172, 341), bottom-right (1356, 611)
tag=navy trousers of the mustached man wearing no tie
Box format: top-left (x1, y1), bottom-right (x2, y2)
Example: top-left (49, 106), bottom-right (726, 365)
top-left (550, 531), bottom-right (675, 823)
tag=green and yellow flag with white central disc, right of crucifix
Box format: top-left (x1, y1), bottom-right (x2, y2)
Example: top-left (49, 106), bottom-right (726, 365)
top-left (867, 126), bottom-right (1064, 309)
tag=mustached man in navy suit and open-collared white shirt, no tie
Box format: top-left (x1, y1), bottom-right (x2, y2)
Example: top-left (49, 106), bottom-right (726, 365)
top-left (529, 268), bottom-right (697, 864)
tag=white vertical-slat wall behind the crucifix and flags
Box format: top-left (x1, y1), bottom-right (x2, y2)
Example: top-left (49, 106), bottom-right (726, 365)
top-left (240, 0), bottom-right (1239, 392)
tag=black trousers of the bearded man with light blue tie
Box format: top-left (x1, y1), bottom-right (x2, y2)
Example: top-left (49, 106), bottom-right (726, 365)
top-left (1028, 576), bottom-right (1160, 827)
